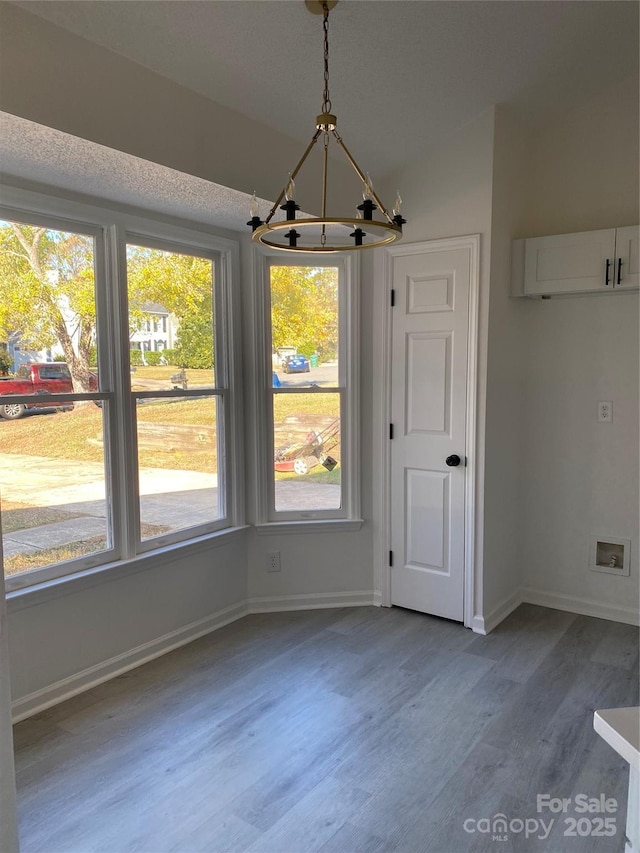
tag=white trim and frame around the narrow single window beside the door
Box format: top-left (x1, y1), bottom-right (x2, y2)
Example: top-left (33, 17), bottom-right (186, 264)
top-left (252, 246), bottom-right (363, 534)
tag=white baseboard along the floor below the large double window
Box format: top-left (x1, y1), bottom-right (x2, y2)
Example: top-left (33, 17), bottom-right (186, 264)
top-left (12, 601), bottom-right (249, 723)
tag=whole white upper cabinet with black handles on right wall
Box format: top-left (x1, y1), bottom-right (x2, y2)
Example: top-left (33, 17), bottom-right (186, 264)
top-left (513, 226), bottom-right (640, 296)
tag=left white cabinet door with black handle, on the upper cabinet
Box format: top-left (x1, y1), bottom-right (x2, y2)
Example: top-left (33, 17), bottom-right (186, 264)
top-left (524, 228), bottom-right (626, 296)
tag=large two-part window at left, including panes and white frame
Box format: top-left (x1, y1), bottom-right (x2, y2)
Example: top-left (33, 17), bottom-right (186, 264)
top-left (0, 191), bottom-right (241, 590)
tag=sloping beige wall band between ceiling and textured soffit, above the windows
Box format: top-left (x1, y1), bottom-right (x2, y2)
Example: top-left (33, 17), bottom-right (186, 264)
top-left (0, 3), bottom-right (359, 216)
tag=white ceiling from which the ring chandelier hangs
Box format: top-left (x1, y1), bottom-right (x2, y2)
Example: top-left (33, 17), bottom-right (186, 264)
top-left (7, 0), bottom-right (638, 174)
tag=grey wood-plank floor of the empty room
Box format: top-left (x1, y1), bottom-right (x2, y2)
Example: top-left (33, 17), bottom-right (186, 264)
top-left (16, 605), bottom-right (638, 853)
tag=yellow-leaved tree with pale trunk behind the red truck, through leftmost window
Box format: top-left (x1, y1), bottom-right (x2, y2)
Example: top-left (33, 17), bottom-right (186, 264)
top-left (0, 222), bottom-right (95, 392)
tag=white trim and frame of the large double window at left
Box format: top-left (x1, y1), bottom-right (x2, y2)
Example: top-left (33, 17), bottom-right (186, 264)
top-left (0, 187), bottom-right (244, 594)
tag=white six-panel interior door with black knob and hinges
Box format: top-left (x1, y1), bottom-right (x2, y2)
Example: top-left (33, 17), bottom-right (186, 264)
top-left (391, 240), bottom-right (472, 621)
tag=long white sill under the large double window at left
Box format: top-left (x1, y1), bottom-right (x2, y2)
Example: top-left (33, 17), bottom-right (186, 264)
top-left (7, 525), bottom-right (249, 613)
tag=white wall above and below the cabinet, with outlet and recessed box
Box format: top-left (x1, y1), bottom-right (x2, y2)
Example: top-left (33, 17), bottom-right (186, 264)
top-left (517, 79), bottom-right (640, 620)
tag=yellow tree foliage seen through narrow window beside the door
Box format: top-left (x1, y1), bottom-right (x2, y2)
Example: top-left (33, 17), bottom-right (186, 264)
top-left (271, 266), bottom-right (338, 360)
